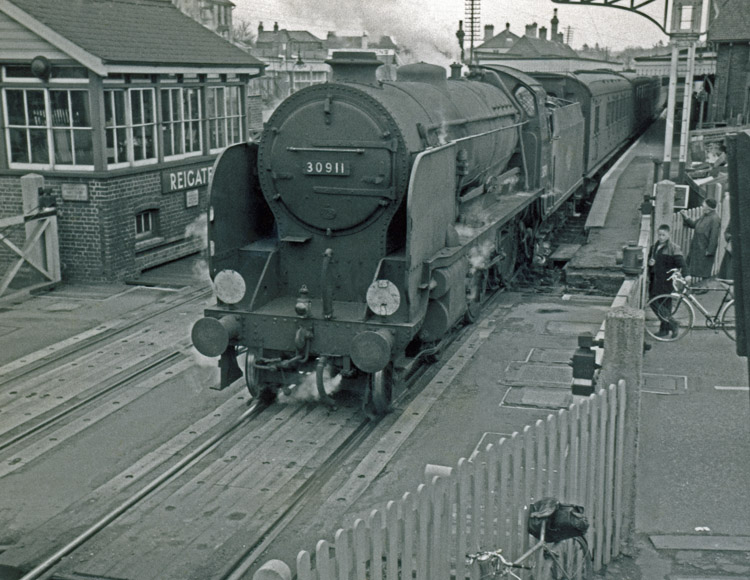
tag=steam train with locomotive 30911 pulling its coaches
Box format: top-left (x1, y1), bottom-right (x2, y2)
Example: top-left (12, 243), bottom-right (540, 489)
top-left (192, 53), bottom-right (659, 414)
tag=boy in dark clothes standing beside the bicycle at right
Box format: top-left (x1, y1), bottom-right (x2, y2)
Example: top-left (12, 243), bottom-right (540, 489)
top-left (648, 224), bottom-right (685, 336)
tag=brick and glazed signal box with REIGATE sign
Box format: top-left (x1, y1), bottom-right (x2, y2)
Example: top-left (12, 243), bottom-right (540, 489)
top-left (0, 0), bottom-right (263, 281)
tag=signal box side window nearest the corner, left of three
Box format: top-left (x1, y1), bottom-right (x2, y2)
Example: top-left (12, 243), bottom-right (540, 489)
top-left (104, 89), bottom-right (156, 168)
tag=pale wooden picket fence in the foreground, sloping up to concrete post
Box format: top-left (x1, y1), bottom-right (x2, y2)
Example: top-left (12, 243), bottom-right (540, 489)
top-left (280, 381), bottom-right (626, 580)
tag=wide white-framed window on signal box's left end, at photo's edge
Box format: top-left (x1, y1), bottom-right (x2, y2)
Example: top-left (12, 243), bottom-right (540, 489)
top-left (3, 86), bottom-right (94, 169)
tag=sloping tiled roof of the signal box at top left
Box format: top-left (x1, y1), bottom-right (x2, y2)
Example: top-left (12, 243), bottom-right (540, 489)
top-left (0, 0), bottom-right (264, 69)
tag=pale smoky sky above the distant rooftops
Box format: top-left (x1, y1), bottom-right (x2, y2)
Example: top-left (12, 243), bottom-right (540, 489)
top-left (233, 0), bottom-right (667, 62)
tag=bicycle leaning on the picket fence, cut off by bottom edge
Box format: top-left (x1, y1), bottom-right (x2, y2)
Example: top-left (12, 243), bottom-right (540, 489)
top-left (466, 500), bottom-right (593, 580)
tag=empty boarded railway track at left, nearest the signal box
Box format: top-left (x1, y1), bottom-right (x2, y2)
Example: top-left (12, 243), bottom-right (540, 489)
top-left (0, 290), bottom-right (212, 462)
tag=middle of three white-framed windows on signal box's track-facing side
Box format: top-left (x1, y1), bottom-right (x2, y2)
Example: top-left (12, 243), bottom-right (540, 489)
top-left (161, 87), bottom-right (203, 160)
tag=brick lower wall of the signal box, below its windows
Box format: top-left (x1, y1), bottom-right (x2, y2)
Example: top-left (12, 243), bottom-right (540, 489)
top-left (0, 162), bottom-right (208, 282)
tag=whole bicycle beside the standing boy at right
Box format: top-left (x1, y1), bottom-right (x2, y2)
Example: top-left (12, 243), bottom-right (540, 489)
top-left (645, 269), bottom-right (737, 342)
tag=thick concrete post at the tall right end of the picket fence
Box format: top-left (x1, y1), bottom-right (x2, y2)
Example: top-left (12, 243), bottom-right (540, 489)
top-left (599, 306), bottom-right (645, 553)
